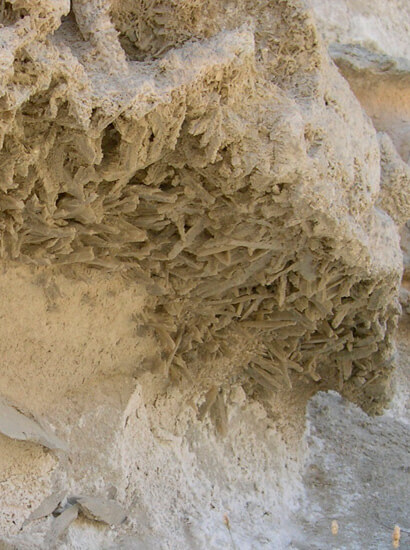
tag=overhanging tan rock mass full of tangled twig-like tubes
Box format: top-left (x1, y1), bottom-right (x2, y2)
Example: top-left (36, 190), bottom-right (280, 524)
top-left (0, 0), bottom-right (402, 431)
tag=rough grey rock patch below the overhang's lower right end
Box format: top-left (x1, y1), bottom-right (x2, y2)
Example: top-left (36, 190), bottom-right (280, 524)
top-left (295, 394), bottom-right (410, 550)
